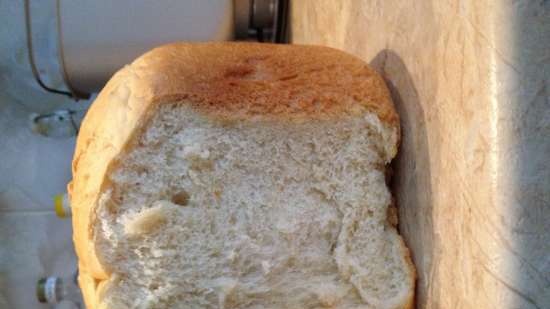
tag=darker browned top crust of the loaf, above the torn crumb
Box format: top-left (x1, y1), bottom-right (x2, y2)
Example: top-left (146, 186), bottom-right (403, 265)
top-left (132, 43), bottom-right (398, 125)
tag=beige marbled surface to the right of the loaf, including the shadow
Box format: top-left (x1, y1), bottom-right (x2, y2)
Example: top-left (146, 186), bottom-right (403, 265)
top-left (291, 0), bottom-right (550, 309)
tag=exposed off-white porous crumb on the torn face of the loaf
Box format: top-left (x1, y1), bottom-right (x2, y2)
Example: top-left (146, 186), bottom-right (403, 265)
top-left (93, 104), bottom-right (414, 309)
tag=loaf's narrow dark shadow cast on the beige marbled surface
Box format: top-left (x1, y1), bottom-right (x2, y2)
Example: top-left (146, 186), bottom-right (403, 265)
top-left (370, 50), bottom-right (439, 308)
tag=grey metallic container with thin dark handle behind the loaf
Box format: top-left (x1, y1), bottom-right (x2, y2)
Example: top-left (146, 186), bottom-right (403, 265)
top-left (25, 0), bottom-right (287, 99)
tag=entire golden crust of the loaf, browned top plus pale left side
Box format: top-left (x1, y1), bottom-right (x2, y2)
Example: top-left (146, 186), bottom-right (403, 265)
top-left (69, 43), bottom-right (399, 308)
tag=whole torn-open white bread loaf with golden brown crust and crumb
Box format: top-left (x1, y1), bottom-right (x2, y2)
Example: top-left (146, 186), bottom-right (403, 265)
top-left (69, 43), bottom-right (415, 309)
